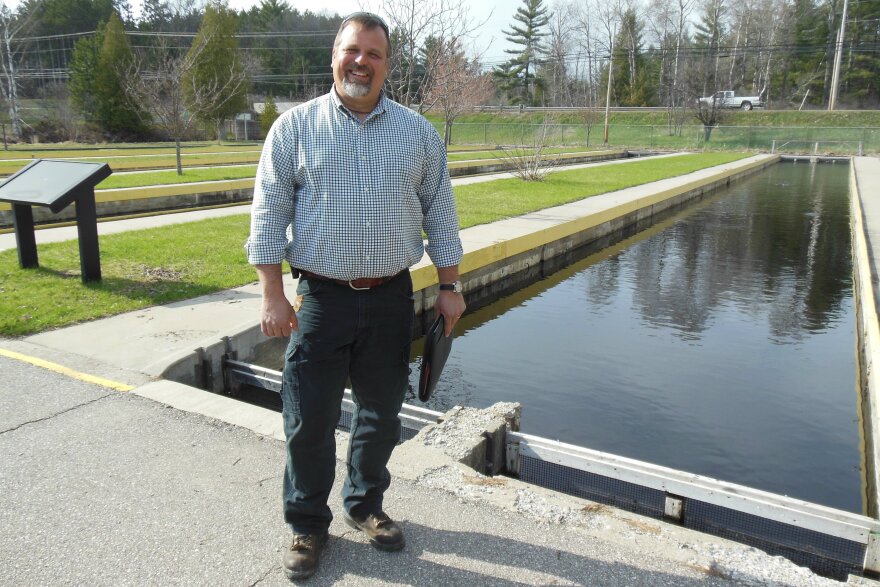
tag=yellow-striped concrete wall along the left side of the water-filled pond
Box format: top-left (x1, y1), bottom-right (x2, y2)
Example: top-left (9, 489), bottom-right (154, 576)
top-left (161, 155), bottom-right (779, 391)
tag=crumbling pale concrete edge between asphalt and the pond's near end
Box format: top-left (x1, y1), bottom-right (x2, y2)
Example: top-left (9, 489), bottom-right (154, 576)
top-left (131, 381), bottom-right (852, 585)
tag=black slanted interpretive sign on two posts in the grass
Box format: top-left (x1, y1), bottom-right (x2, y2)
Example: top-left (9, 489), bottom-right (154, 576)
top-left (0, 159), bottom-right (113, 282)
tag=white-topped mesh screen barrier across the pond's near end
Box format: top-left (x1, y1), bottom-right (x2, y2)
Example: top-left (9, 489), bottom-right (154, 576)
top-left (223, 359), bottom-right (880, 580)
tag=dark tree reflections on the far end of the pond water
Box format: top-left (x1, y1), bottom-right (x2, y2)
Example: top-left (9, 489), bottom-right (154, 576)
top-left (585, 164), bottom-right (852, 340)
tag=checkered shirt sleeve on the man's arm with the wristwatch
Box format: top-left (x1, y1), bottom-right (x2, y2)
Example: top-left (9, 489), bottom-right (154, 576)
top-left (418, 123), bottom-right (462, 267)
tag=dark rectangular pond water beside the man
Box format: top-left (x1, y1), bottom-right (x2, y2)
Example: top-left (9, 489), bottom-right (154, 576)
top-left (407, 164), bottom-right (862, 512)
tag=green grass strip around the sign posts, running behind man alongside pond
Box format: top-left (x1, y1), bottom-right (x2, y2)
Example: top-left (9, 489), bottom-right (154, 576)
top-left (0, 153), bottom-right (746, 336)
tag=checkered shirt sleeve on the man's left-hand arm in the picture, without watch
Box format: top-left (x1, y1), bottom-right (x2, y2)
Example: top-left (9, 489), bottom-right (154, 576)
top-left (245, 116), bottom-right (297, 265)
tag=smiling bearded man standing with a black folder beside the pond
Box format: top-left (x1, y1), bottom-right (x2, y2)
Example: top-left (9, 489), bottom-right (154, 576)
top-left (246, 12), bottom-right (465, 579)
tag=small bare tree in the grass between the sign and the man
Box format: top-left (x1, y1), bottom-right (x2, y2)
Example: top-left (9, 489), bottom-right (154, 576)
top-left (119, 37), bottom-right (248, 175)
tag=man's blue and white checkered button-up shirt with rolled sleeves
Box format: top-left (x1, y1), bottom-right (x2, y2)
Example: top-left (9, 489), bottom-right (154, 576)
top-left (245, 90), bottom-right (462, 280)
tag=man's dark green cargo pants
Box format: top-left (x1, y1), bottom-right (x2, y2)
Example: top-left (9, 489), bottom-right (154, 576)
top-left (281, 271), bottom-right (413, 534)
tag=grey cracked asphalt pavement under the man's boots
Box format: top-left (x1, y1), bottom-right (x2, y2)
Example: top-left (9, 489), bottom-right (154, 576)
top-left (0, 357), bottom-right (834, 586)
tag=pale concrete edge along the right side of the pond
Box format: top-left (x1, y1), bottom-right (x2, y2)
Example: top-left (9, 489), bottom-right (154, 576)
top-left (850, 157), bottom-right (880, 518)
